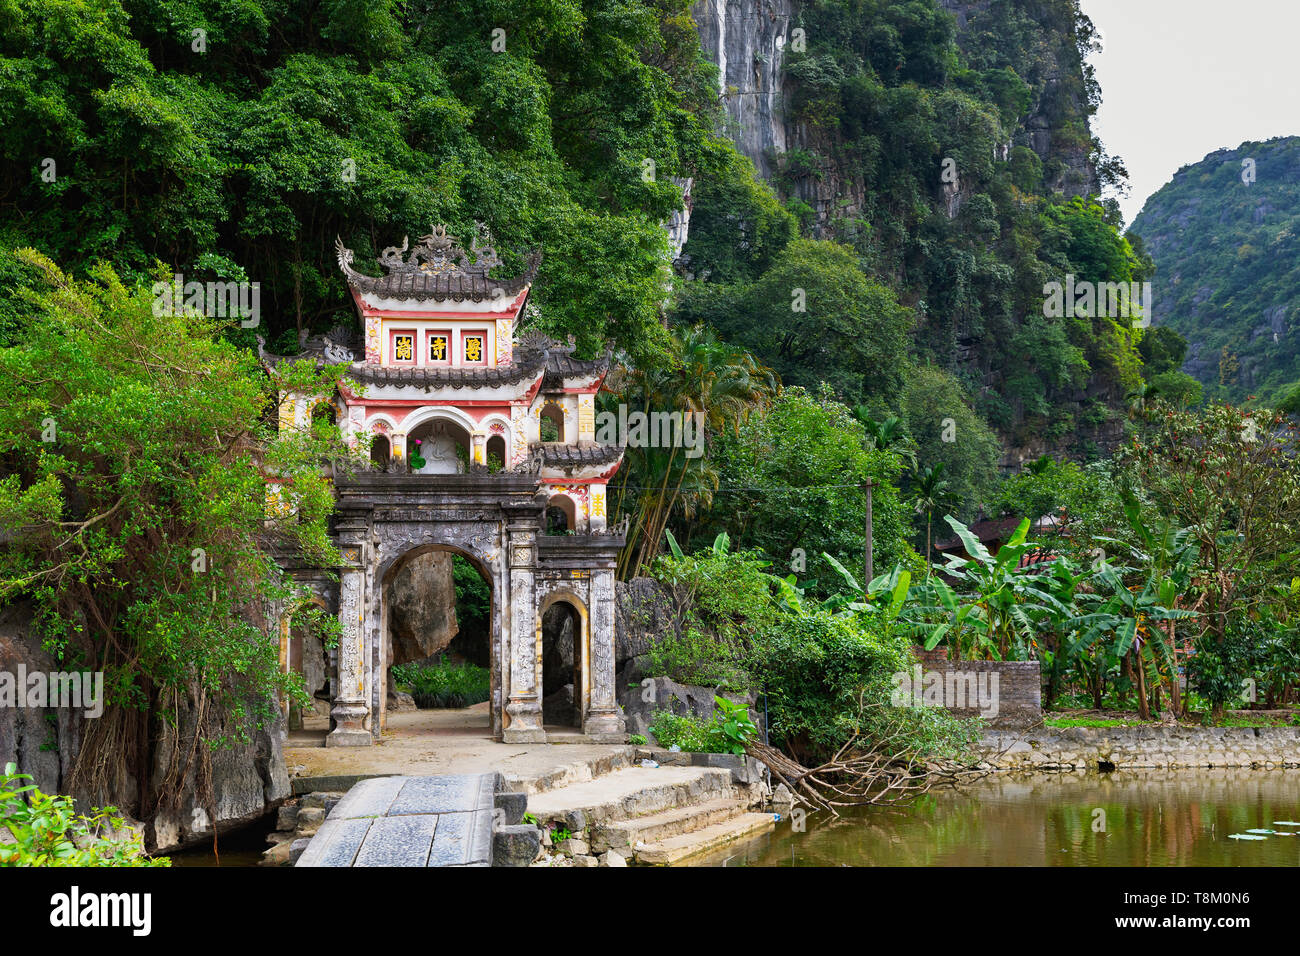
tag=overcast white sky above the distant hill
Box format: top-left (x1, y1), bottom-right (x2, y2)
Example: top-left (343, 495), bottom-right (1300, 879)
top-left (1080, 0), bottom-right (1300, 225)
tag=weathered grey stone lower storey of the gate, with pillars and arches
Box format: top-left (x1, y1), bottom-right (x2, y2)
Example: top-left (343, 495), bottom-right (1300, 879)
top-left (325, 472), bottom-right (624, 747)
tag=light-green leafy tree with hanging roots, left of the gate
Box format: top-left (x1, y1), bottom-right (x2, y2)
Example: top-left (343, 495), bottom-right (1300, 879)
top-left (0, 250), bottom-right (350, 793)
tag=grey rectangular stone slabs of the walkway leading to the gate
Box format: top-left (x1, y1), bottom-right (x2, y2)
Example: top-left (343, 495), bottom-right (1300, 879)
top-left (296, 774), bottom-right (497, 866)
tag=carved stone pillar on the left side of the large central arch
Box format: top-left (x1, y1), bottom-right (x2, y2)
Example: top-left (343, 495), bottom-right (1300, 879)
top-left (325, 538), bottom-right (374, 747)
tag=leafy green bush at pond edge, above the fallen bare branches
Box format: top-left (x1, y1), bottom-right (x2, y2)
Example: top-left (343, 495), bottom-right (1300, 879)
top-left (653, 537), bottom-right (974, 760)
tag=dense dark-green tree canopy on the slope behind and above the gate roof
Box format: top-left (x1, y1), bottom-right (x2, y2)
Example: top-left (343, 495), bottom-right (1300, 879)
top-left (0, 0), bottom-right (743, 360)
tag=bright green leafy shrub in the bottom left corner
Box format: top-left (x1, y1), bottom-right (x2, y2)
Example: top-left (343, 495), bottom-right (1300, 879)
top-left (0, 763), bottom-right (172, 866)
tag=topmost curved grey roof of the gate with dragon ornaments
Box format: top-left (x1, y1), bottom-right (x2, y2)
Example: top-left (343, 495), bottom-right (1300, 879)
top-left (334, 226), bottom-right (541, 302)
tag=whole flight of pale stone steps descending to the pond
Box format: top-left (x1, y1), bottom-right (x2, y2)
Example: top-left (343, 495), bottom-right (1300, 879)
top-left (528, 750), bottom-right (775, 866)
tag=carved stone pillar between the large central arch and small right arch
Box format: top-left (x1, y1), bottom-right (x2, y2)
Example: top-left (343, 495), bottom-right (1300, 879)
top-left (502, 524), bottom-right (546, 744)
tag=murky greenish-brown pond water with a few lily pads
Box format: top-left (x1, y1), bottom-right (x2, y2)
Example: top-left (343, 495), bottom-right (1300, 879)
top-left (685, 770), bottom-right (1300, 866)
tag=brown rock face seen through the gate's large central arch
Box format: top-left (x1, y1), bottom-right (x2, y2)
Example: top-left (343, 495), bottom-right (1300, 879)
top-left (389, 551), bottom-right (459, 663)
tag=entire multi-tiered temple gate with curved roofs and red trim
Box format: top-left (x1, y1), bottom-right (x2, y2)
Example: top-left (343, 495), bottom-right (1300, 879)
top-left (264, 228), bottom-right (624, 747)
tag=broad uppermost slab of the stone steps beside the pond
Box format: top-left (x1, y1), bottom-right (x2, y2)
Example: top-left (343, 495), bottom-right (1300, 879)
top-left (528, 766), bottom-right (735, 831)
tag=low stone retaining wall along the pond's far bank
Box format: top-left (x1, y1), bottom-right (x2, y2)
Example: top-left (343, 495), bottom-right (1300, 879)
top-left (980, 726), bottom-right (1300, 770)
